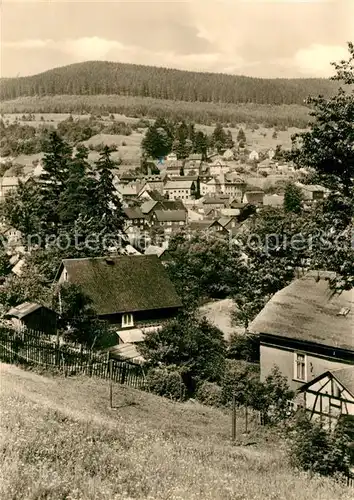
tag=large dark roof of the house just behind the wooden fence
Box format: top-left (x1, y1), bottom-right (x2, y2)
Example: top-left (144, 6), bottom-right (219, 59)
top-left (57, 255), bottom-right (181, 316)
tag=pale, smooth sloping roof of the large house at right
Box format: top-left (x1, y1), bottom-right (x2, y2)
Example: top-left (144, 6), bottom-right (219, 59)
top-left (250, 271), bottom-right (354, 351)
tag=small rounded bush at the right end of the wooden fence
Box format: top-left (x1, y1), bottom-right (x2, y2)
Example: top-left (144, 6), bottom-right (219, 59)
top-left (146, 365), bottom-right (185, 401)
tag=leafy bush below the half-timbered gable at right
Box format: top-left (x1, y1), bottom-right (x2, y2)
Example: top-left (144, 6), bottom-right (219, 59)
top-left (289, 411), bottom-right (350, 476)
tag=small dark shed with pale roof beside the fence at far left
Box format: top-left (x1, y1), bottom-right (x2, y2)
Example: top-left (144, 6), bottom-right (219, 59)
top-left (5, 302), bottom-right (57, 335)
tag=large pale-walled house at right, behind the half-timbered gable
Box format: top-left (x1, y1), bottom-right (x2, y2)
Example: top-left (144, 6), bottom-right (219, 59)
top-left (250, 271), bottom-right (354, 390)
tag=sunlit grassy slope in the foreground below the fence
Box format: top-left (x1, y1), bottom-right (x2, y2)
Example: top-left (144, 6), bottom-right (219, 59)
top-left (0, 364), bottom-right (351, 500)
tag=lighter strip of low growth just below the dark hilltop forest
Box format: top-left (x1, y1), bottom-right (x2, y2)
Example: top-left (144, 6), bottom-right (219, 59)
top-left (0, 95), bottom-right (310, 128)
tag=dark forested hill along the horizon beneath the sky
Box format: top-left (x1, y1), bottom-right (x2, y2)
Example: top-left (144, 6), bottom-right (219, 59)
top-left (0, 61), bottom-right (337, 104)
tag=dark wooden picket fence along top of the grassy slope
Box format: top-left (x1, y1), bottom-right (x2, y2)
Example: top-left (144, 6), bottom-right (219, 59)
top-left (0, 330), bottom-right (145, 389)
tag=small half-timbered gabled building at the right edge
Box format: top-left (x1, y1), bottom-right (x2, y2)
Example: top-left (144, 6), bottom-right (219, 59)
top-left (297, 366), bottom-right (354, 428)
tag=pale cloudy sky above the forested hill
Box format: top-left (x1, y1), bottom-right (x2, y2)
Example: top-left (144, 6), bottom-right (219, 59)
top-left (0, 0), bottom-right (354, 78)
